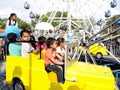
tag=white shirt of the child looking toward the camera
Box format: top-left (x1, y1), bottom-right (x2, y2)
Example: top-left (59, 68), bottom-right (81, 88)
top-left (21, 43), bottom-right (34, 57)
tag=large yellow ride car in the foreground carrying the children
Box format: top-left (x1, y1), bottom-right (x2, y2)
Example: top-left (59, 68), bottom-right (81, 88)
top-left (6, 42), bottom-right (118, 90)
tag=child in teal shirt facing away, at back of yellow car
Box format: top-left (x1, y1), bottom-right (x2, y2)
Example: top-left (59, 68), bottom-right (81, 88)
top-left (7, 33), bottom-right (21, 56)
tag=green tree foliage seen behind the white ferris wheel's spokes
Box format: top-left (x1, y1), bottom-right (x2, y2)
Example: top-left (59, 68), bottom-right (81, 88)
top-left (31, 11), bottom-right (95, 30)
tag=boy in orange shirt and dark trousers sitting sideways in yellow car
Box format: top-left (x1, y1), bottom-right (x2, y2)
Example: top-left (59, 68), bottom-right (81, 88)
top-left (44, 37), bottom-right (64, 84)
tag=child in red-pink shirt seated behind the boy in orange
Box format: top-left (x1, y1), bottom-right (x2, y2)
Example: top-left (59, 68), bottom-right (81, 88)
top-left (36, 36), bottom-right (47, 50)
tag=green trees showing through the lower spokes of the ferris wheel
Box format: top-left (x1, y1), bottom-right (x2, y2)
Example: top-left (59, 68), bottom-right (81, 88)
top-left (31, 11), bottom-right (95, 30)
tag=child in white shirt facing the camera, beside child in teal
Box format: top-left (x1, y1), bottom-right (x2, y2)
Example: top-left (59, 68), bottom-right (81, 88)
top-left (20, 30), bottom-right (39, 57)
